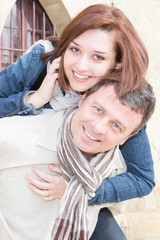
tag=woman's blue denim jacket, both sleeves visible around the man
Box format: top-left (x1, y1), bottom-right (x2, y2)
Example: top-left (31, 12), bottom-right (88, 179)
top-left (0, 42), bottom-right (155, 204)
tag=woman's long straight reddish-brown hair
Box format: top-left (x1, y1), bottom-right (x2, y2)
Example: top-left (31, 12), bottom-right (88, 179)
top-left (42, 4), bottom-right (148, 94)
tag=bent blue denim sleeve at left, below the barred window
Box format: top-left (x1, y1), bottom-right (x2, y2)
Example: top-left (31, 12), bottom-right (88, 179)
top-left (0, 44), bottom-right (45, 118)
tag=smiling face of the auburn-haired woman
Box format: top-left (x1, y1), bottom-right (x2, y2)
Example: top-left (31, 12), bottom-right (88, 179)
top-left (64, 29), bottom-right (116, 92)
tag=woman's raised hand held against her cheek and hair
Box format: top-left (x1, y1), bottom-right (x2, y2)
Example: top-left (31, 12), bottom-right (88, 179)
top-left (27, 57), bottom-right (61, 109)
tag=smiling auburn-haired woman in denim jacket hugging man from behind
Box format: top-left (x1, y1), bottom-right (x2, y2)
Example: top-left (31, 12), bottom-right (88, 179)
top-left (0, 4), bottom-right (154, 239)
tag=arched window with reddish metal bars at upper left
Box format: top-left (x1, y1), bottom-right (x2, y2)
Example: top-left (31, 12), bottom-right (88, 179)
top-left (0, 0), bottom-right (55, 70)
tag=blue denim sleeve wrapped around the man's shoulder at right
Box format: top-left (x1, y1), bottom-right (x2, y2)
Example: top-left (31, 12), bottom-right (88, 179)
top-left (89, 126), bottom-right (155, 204)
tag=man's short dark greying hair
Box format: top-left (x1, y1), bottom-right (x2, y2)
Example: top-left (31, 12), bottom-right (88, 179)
top-left (86, 79), bottom-right (156, 134)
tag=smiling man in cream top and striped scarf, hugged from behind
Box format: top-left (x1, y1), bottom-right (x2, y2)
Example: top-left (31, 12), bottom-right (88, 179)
top-left (0, 80), bottom-right (155, 240)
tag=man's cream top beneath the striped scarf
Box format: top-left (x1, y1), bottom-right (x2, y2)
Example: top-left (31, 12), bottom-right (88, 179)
top-left (0, 109), bottom-right (126, 240)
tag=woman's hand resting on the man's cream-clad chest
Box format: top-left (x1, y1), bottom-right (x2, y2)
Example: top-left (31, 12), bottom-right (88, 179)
top-left (25, 165), bottom-right (66, 202)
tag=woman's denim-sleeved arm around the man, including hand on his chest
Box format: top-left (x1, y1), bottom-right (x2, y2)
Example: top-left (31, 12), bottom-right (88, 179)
top-left (26, 127), bottom-right (155, 204)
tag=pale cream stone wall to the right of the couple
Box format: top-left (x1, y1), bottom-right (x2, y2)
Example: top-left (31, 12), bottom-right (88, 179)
top-left (116, 0), bottom-right (160, 240)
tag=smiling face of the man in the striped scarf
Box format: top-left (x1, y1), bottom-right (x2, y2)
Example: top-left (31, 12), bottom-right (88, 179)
top-left (71, 85), bottom-right (143, 155)
